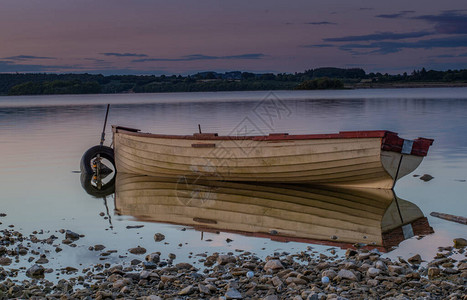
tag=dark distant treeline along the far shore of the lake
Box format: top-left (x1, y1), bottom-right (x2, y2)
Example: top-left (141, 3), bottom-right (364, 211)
top-left (0, 68), bottom-right (467, 95)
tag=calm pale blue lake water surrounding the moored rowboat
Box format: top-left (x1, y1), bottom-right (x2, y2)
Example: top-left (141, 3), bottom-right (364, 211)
top-left (0, 88), bottom-right (467, 276)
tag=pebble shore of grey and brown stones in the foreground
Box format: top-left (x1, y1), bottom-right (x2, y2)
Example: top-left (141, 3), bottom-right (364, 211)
top-left (0, 216), bottom-right (467, 300)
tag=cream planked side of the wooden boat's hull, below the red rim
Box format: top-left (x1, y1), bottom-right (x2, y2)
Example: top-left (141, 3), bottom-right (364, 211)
top-left (114, 132), bottom-right (393, 189)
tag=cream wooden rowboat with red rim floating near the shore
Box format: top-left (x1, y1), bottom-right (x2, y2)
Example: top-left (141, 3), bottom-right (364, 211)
top-left (113, 126), bottom-right (433, 189)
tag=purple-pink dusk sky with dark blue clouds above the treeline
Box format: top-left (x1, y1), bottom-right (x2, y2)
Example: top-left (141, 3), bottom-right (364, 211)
top-left (0, 0), bottom-right (467, 75)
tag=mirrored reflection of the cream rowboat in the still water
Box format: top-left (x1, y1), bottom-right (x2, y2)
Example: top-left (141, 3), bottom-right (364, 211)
top-left (115, 173), bottom-right (433, 251)
